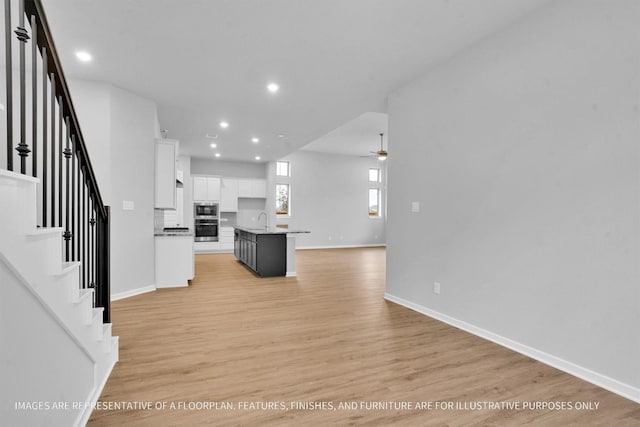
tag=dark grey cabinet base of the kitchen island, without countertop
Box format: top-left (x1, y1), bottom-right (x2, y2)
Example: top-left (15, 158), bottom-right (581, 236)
top-left (234, 230), bottom-right (287, 277)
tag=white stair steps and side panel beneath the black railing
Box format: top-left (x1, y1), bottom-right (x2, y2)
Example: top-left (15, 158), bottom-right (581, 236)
top-left (0, 170), bottom-right (118, 426)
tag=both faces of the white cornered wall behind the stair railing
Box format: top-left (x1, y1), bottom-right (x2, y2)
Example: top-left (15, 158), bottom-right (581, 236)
top-left (69, 79), bottom-right (158, 300)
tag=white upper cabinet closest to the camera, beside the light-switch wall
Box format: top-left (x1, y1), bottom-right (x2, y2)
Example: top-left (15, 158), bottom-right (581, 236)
top-left (154, 139), bottom-right (178, 209)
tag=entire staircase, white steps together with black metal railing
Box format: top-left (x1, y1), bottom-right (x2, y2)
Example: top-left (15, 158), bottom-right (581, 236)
top-left (0, 0), bottom-right (118, 427)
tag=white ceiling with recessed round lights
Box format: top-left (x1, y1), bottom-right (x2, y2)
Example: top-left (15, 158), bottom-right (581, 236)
top-left (43, 0), bottom-right (549, 161)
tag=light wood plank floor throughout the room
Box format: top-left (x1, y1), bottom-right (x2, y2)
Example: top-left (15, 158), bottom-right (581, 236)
top-left (89, 248), bottom-right (640, 426)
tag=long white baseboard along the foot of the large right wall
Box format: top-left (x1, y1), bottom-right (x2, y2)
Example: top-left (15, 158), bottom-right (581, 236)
top-left (384, 292), bottom-right (640, 403)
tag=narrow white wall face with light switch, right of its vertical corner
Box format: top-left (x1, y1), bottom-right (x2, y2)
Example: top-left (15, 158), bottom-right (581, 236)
top-left (111, 87), bottom-right (156, 294)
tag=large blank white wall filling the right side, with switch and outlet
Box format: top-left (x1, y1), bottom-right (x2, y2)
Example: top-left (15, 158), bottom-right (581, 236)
top-left (387, 0), bottom-right (640, 399)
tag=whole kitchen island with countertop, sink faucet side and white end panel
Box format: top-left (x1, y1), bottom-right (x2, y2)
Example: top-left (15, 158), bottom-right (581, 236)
top-left (234, 226), bottom-right (309, 277)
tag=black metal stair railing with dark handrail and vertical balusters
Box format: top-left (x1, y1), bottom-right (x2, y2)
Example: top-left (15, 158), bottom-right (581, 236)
top-left (0, 0), bottom-right (111, 322)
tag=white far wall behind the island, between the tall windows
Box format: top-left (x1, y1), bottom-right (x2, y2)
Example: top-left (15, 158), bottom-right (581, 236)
top-left (276, 151), bottom-right (386, 247)
